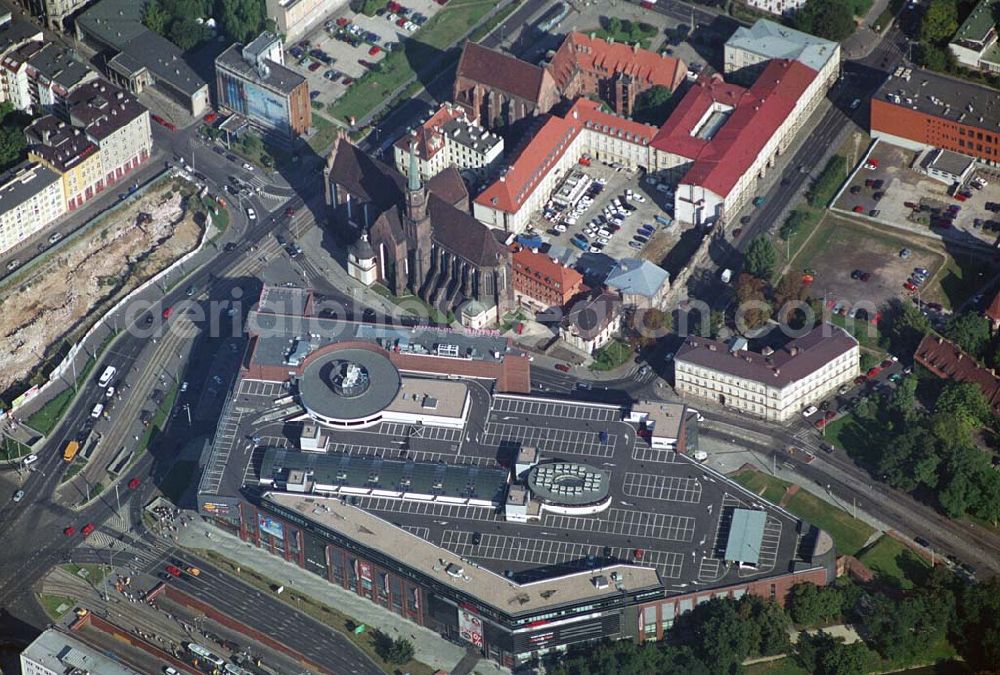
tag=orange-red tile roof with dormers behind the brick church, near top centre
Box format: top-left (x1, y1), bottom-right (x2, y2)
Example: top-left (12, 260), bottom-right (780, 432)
top-left (549, 33), bottom-right (687, 91)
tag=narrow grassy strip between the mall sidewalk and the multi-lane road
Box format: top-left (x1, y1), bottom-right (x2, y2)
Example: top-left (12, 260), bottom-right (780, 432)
top-left (194, 549), bottom-right (435, 675)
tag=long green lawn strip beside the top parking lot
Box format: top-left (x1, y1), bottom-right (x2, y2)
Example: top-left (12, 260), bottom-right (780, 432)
top-left (327, 0), bottom-right (496, 121)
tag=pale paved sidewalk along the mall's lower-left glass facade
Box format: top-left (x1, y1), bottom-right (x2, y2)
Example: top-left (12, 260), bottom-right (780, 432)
top-left (177, 519), bottom-right (510, 675)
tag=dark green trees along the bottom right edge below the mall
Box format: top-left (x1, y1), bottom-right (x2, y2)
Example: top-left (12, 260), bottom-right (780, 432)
top-left (550, 566), bottom-right (1000, 675)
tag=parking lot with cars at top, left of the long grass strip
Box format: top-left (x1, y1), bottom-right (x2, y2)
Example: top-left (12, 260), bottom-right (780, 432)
top-left (285, 0), bottom-right (441, 104)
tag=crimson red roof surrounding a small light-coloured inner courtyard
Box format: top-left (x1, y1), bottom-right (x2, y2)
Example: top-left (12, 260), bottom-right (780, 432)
top-left (652, 59), bottom-right (817, 197)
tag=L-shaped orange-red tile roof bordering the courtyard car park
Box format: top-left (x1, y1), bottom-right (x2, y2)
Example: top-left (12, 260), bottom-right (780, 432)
top-left (476, 98), bottom-right (656, 213)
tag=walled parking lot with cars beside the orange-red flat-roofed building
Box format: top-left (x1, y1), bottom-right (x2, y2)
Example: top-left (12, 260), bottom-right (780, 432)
top-left (835, 143), bottom-right (1000, 244)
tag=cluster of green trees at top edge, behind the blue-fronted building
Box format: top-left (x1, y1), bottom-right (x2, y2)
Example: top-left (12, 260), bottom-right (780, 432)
top-left (142, 0), bottom-right (273, 51)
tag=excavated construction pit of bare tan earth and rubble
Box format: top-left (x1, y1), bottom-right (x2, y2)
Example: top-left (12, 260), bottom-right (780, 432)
top-left (0, 179), bottom-right (205, 391)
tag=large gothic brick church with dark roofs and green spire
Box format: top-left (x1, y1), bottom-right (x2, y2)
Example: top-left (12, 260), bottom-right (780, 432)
top-left (323, 135), bottom-right (513, 324)
